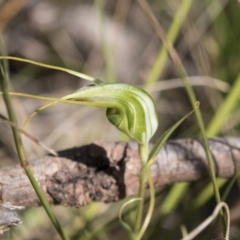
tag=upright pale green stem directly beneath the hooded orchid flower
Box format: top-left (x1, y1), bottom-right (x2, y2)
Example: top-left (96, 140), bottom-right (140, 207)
top-left (134, 144), bottom-right (149, 236)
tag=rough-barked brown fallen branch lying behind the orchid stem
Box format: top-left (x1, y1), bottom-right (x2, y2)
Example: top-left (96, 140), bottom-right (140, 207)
top-left (0, 138), bottom-right (240, 207)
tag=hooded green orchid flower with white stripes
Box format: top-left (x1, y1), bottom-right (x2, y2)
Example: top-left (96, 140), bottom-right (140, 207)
top-left (63, 83), bottom-right (158, 144)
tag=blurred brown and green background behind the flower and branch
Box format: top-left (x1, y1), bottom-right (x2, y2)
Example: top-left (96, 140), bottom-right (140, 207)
top-left (0, 0), bottom-right (240, 240)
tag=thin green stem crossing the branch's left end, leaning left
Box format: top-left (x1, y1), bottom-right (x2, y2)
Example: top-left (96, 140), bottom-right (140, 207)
top-left (0, 62), bottom-right (69, 240)
